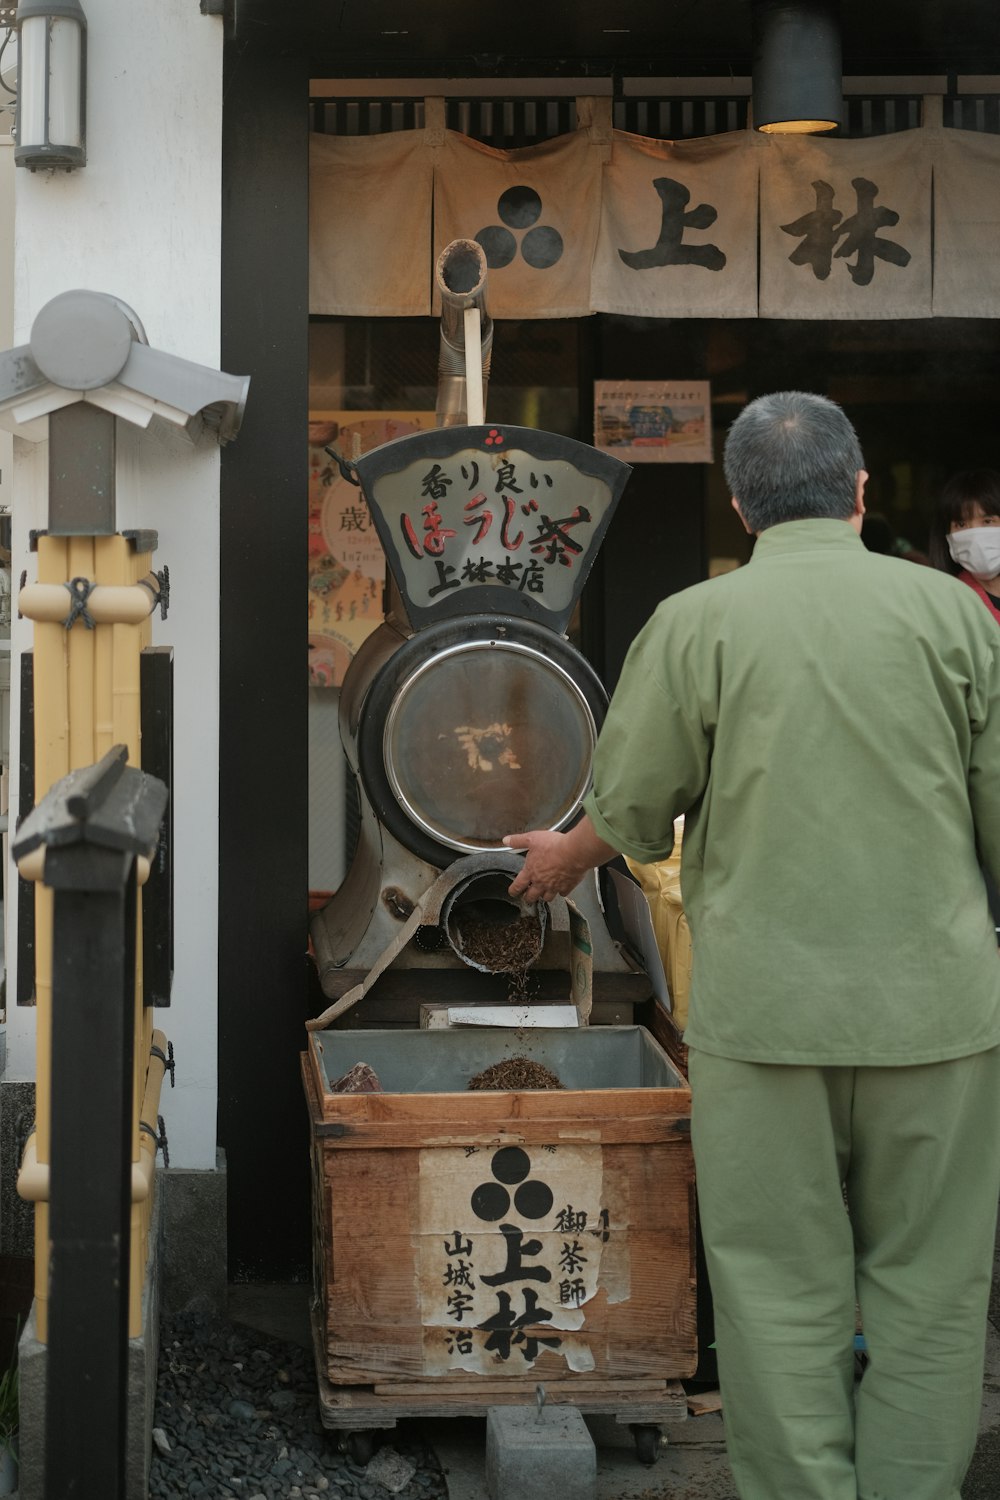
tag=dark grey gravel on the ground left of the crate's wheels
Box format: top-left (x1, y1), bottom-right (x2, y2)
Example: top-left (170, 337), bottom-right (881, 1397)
top-left (148, 1313), bottom-right (448, 1500)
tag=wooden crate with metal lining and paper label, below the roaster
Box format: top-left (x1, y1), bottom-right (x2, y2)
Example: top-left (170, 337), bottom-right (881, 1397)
top-left (303, 1026), bottom-right (697, 1398)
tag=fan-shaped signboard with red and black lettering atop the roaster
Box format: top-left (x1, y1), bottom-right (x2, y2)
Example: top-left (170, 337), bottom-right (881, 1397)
top-left (357, 426), bottom-right (630, 632)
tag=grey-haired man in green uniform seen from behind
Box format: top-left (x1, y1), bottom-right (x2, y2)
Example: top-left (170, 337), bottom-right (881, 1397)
top-left (505, 392), bottom-right (1000, 1500)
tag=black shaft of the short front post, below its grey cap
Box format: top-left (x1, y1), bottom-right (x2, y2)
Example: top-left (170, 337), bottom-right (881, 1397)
top-left (45, 876), bottom-right (135, 1500)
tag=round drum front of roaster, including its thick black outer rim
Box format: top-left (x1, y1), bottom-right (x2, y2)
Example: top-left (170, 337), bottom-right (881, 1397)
top-left (358, 617), bottom-right (606, 866)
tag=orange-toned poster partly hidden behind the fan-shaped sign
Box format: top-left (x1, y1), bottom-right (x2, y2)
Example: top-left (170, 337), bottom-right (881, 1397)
top-left (309, 411), bottom-right (435, 687)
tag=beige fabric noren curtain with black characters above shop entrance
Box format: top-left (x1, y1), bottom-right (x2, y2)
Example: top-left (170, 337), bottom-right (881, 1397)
top-left (310, 126), bottom-right (1000, 318)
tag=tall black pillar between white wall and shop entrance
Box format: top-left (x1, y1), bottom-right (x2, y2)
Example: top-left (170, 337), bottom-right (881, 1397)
top-left (219, 38), bottom-right (310, 1281)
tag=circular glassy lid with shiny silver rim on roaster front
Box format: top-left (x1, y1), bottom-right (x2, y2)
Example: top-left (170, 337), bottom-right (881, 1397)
top-left (382, 641), bottom-right (597, 851)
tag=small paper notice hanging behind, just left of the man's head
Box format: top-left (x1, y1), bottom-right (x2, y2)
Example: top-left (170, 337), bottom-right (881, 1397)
top-left (594, 380), bottom-right (712, 464)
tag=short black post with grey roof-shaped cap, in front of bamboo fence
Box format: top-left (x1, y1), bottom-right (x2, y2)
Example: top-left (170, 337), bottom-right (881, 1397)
top-left (13, 746), bottom-right (166, 1500)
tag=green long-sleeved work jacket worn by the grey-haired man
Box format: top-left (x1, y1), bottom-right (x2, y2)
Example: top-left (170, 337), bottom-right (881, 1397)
top-left (586, 521), bottom-right (1000, 1067)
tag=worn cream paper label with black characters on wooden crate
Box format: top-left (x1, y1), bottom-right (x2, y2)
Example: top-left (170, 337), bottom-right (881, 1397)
top-left (417, 1146), bottom-right (628, 1377)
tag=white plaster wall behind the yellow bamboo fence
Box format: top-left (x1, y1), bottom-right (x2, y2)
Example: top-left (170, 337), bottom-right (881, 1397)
top-left (7, 0), bottom-right (224, 1167)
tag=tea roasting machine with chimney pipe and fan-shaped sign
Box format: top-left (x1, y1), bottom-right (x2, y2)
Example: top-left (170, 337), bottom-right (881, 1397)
top-left (310, 240), bottom-right (649, 1028)
